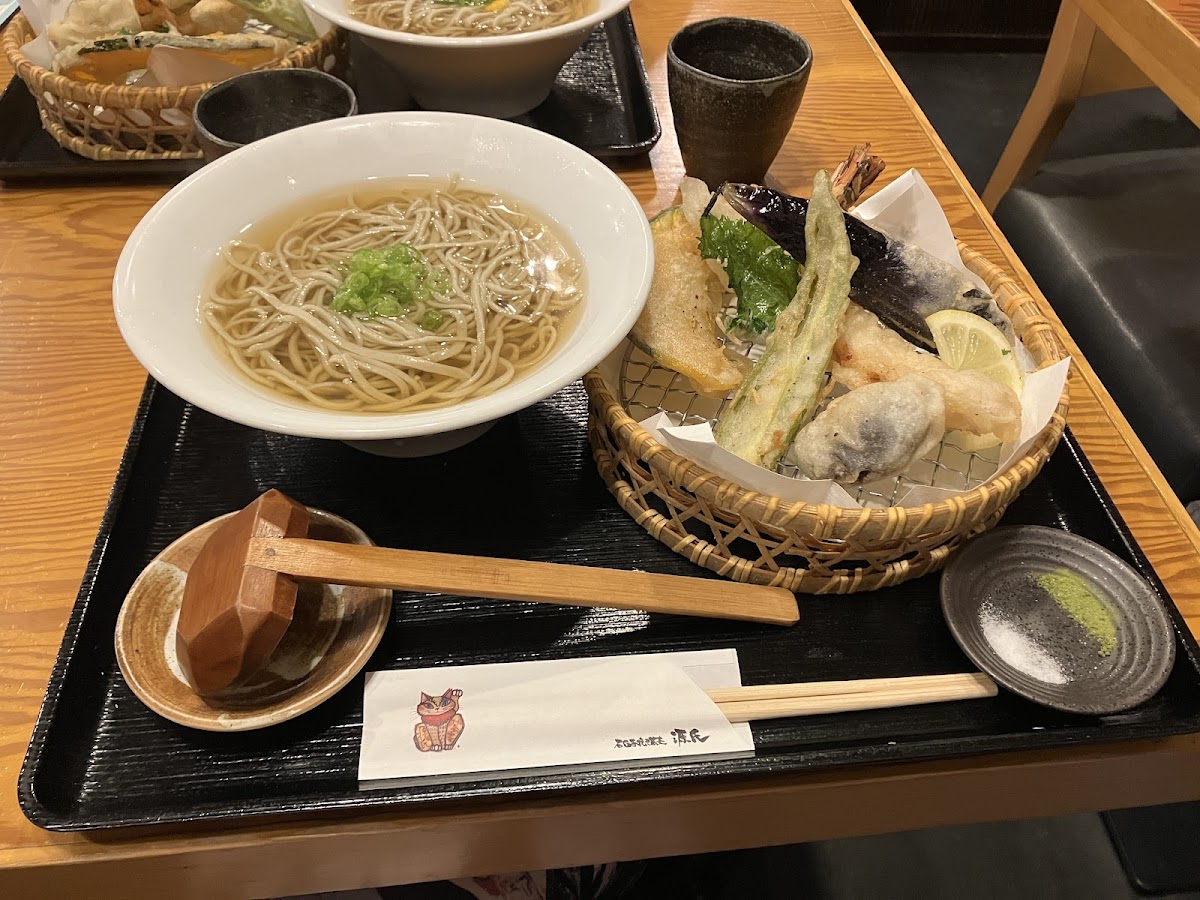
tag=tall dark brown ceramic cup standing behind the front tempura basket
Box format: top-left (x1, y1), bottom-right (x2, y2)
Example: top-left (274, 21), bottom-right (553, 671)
top-left (667, 17), bottom-right (812, 188)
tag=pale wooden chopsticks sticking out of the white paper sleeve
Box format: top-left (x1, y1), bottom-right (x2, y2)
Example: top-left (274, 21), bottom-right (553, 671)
top-left (708, 672), bottom-right (997, 722)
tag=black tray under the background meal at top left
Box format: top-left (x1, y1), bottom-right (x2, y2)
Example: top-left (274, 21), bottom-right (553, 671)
top-left (0, 10), bottom-right (662, 181)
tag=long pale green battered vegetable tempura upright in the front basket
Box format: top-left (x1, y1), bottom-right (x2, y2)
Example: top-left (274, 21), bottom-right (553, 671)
top-left (715, 172), bottom-right (858, 469)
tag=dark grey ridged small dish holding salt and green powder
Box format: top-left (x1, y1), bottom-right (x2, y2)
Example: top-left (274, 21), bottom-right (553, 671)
top-left (941, 526), bottom-right (1175, 715)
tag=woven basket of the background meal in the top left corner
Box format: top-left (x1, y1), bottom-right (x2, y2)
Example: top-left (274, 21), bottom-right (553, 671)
top-left (4, 13), bottom-right (349, 161)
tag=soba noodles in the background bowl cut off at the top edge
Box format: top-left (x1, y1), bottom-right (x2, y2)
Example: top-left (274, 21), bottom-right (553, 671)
top-left (346, 0), bottom-right (590, 37)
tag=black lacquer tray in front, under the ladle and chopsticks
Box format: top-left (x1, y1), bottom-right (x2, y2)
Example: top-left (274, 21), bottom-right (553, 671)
top-left (19, 382), bottom-right (1200, 829)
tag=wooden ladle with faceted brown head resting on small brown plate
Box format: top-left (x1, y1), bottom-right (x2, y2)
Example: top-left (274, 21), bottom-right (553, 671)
top-left (175, 491), bottom-right (799, 696)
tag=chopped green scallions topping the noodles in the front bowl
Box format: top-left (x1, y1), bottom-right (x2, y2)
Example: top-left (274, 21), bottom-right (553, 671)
top-left (330, 244), bottom-right (450, 331)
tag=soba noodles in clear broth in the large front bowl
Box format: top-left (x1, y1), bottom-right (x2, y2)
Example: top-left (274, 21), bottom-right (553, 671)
top-left (200, 182), bottom-right (582, 413)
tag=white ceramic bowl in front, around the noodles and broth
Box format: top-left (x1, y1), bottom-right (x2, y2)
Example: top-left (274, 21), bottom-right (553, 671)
top-left (113, 113), bottom-right (654, 452)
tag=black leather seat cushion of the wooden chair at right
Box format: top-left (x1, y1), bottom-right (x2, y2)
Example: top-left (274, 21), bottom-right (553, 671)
top-left (995, 146), bottom-right (1200, 503)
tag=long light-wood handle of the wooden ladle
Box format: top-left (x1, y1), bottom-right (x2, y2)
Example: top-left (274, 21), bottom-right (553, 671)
top-left (246, 538), bottom-right (799, 625)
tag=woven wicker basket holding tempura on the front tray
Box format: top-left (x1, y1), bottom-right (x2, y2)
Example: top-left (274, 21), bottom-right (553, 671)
top-left (584, 244), bottom-right (1067, 594)
